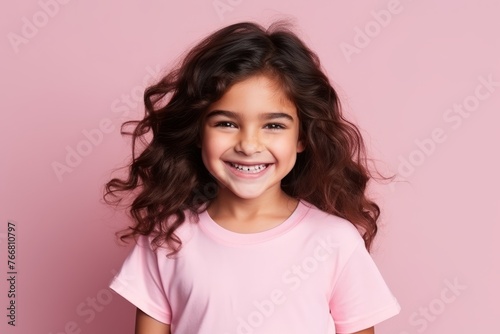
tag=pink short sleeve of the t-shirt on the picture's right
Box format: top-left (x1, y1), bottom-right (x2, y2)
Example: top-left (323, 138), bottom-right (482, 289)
top-left (329, 240), bottom-right (401, 333)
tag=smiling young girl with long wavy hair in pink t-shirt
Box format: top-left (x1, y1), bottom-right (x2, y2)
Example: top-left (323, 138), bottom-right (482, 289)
top-left (105, 23), bottom-right (400, 334)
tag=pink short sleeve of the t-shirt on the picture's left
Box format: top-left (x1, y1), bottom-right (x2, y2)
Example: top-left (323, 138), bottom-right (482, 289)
top-left (109, 236), bottom-right (172, 324)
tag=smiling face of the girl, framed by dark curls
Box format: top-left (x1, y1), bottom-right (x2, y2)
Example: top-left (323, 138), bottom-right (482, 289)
top-left (201, 75), bottom-right (304, 199)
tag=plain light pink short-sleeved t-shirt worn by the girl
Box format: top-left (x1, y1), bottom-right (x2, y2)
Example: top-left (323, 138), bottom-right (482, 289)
top-left (110, 201), bottom-right (400, 334)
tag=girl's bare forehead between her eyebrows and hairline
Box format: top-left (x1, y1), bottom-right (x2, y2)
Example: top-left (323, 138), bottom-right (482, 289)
top-left (209, 75), bottom-right (297, 116)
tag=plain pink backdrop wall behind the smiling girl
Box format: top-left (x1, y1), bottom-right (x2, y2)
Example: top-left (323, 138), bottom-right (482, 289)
top-left (0, 0), bottom-right (500, 334)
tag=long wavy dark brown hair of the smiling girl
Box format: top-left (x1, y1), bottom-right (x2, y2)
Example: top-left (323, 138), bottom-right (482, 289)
top-left (104, 22), bottom-right (394, 254)
